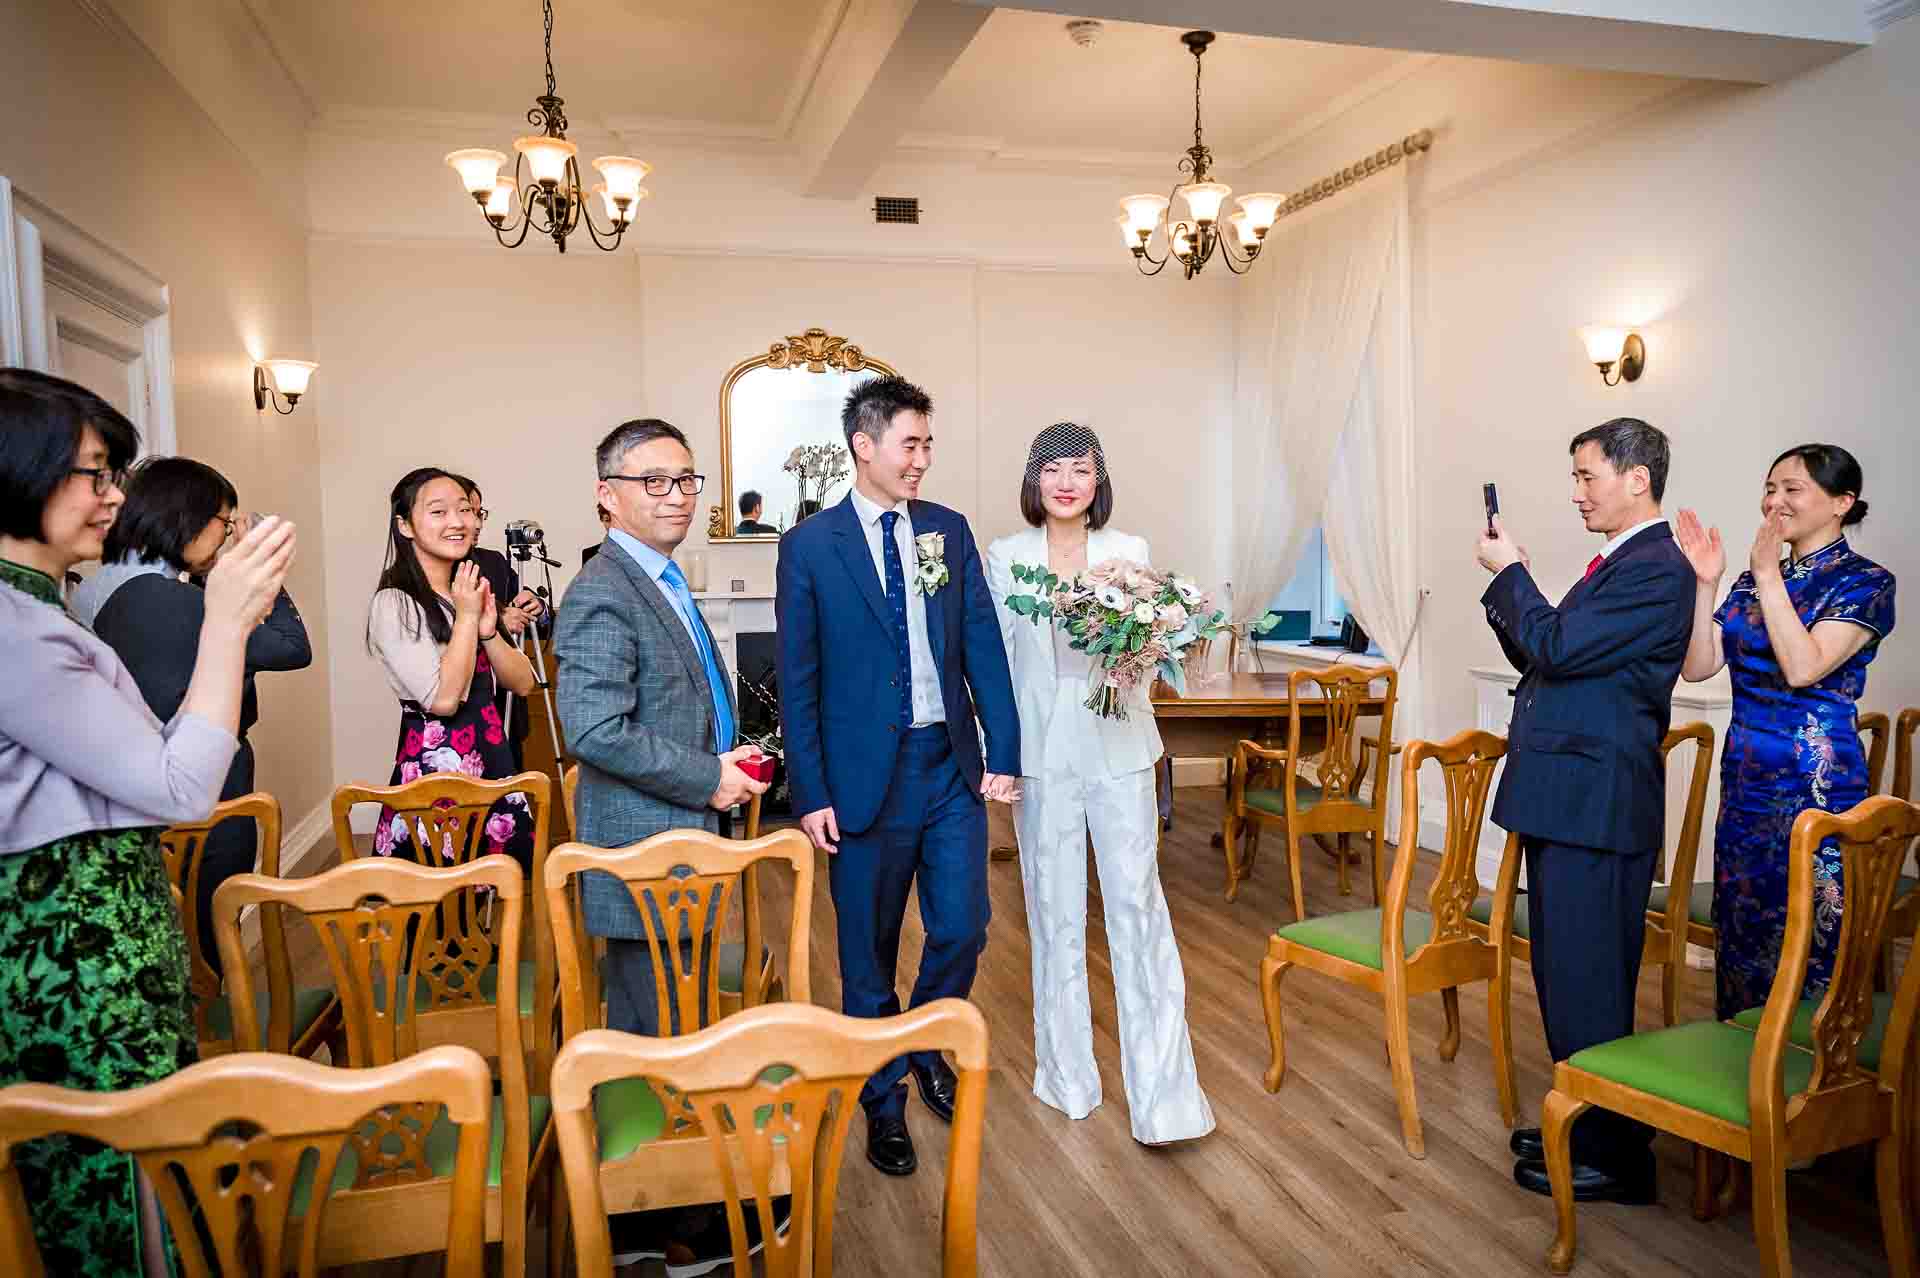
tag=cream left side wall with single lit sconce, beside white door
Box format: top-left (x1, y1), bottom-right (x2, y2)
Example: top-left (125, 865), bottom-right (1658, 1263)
top-left (0, 0), bottom-right (332, 835)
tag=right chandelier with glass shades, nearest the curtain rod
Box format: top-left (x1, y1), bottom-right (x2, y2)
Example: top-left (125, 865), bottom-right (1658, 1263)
top-left (1114, 31), bottom-right (1286, 280)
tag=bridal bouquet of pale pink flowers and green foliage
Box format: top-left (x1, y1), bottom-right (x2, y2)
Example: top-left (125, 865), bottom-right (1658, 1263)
top-left (1006, 558), bottom-right (1227, 720)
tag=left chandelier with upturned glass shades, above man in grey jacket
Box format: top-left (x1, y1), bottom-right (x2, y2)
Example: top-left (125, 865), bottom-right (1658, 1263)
top-left (447, 0), bottom-right (653, 253)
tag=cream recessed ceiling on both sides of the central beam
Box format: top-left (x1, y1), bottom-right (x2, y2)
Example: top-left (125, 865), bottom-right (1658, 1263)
top-left (248, 0), bottom-right (1407, 165)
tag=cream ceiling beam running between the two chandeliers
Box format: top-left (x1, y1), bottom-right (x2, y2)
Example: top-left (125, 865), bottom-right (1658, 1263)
top-left (791, 0), bottom-right (993, 200)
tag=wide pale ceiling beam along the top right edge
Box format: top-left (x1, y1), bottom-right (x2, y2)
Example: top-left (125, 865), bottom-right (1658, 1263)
top-left (954, 0), bottom-right (1874, 84)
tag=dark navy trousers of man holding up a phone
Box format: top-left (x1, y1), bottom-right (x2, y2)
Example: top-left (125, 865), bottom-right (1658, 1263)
top-left (1523, 839), bottom-right (1659, 1172)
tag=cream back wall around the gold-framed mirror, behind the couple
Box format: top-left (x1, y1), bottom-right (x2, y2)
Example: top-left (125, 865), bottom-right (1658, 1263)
top-left (299, 236), bottom-right (1233, 779)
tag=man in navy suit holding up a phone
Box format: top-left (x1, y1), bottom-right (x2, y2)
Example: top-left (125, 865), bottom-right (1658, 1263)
top-left (1478, 416), bottom-right (1693, 1203)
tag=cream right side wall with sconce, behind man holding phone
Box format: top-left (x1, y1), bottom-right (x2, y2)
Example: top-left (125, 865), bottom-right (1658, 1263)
top-left (1244, 21), bottom-right (1920, 748)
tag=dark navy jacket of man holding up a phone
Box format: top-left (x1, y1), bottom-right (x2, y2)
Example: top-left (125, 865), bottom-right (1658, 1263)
top-left (1480, 524), bottom-right (1693, 852)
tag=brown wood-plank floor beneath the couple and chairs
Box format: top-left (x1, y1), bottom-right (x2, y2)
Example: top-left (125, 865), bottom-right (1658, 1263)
top-left (305, 791), bottom-right (1887, 1278)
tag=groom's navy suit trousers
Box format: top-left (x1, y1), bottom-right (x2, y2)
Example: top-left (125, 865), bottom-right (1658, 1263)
top-left (828, 723), bottom-right (991, 1117)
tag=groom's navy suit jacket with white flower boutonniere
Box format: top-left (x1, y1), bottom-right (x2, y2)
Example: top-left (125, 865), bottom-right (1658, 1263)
top-left (774, 497), bottom-right (1020, 833)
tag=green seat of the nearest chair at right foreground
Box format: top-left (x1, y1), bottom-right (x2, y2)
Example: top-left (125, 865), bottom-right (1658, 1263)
top-left (1567, 1021), bottom-right (1812, 1126)
